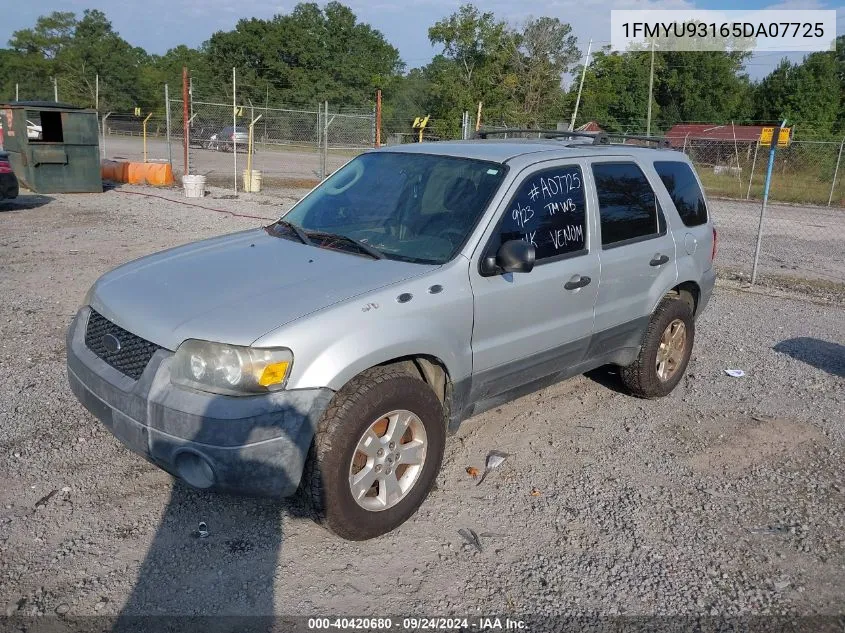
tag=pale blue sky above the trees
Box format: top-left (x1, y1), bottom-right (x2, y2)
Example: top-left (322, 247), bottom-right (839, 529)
top-left (6, 0), bottom-right (845, 79)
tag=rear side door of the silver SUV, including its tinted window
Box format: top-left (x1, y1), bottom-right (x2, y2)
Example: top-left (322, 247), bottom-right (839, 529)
top-left (590, 158), bottom-right (677, 346)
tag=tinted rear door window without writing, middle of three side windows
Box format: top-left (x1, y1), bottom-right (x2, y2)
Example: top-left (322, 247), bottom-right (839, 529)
top-left (593, 163), bottom-right (659, 246)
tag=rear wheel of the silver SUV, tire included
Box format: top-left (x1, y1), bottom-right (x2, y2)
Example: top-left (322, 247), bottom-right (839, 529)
top-left (619, 297), bottom-right (695, 398)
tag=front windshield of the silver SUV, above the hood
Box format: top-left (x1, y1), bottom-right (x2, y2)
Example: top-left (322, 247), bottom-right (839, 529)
top-left (284, 152), bottom-right (505, 264)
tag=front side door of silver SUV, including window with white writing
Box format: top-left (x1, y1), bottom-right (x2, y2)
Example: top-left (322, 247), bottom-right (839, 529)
top-left (470, 161), bottom-right (600, 401)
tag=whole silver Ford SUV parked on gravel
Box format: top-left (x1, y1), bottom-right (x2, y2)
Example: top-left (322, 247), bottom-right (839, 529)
top-left (67, 132), bottom-right (716, 539)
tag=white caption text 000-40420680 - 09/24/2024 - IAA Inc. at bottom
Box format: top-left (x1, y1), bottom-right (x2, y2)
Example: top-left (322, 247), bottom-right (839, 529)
top-left (308, 616), bottom-right (528, 631)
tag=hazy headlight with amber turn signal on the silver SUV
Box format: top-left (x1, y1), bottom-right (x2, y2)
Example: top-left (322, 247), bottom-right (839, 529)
top-left (170, 339), bottom-right (293, 396)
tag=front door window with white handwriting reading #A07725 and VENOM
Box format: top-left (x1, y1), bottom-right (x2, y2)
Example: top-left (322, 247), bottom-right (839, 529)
top-left (497, 165), bottom-right (587, 261)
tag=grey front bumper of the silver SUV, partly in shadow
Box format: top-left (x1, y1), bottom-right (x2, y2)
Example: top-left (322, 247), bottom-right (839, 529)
top-left (67, 307), bottom-right (334, 497)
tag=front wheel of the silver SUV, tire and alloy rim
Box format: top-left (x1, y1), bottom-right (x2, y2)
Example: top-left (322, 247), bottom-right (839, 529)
top-left (299, 366), bottom-right (446, 541)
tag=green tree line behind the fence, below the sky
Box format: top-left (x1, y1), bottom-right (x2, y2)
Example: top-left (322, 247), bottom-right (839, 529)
top-left (0, 2), bottom-right (845, 138)
